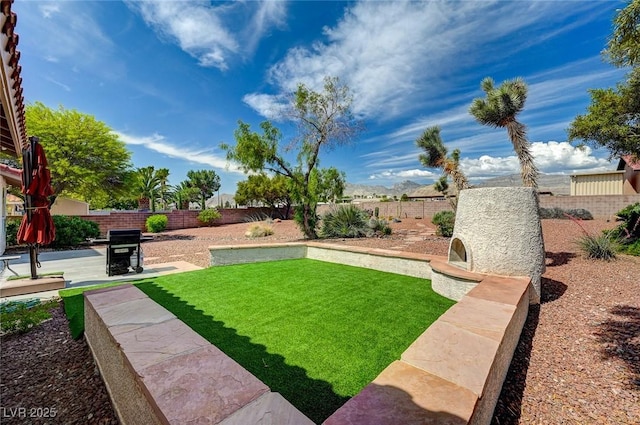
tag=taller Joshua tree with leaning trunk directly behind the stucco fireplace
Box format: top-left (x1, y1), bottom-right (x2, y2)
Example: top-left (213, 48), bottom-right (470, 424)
top-left (469, 77), bottom-right (538, 188)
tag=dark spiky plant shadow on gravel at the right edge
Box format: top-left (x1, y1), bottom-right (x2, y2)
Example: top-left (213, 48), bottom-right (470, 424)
top-left (596, 305), bottom-right (640, 389)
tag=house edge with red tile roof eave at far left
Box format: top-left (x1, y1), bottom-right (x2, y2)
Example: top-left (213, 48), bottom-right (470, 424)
top-left (0, 0), bottom-right (27, 254)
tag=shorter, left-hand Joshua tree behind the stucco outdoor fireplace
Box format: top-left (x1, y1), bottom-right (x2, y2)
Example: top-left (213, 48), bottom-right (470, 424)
top-left (416, 125), bottom-right (469, 192)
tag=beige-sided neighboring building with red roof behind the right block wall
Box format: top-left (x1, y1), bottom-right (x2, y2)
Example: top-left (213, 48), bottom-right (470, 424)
top-left (571, 155), bottom-right (640, 196)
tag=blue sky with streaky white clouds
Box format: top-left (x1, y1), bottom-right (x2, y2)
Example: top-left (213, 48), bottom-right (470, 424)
top-left (13, 0), bottom-right (625, 193)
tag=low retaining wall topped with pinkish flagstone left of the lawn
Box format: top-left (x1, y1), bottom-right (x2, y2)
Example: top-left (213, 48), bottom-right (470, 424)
top-left (84, 284), bottom-right (313, 425)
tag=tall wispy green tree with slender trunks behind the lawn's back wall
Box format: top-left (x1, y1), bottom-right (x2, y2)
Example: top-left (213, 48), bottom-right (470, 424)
top-left (222, 77), bottom-right (361, 239)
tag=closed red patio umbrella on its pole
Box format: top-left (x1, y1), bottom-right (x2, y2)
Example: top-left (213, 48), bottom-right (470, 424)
top-left (17, 137), bottom-right (56, 279)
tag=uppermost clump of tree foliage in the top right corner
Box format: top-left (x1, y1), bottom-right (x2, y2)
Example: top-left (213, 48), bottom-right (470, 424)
top-left (604, 0), bottom-right (640, 66)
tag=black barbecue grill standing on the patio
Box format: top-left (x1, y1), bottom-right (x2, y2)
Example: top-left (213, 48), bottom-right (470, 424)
top-left (107, 229), bottom-right (143, 276)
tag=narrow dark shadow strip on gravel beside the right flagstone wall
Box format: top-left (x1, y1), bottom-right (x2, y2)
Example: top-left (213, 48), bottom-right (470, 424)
top-left (491, 304), bottom-right (540, 425)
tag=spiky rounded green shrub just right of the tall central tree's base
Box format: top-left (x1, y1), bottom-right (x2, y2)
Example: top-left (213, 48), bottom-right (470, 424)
top-left (320, 204), bottom-right (371, 238)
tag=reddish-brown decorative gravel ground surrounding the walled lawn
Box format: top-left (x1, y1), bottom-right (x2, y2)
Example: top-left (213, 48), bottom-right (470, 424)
top-left (0, 219), bottom-right (640, 424)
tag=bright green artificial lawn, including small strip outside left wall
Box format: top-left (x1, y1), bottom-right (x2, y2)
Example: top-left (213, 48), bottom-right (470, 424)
top-left (60, 259), bottom-right (453, 422)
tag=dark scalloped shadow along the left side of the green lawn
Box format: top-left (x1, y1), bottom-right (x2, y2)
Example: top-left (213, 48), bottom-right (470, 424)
top-left (135, 279), bottom-right (349, 423)
